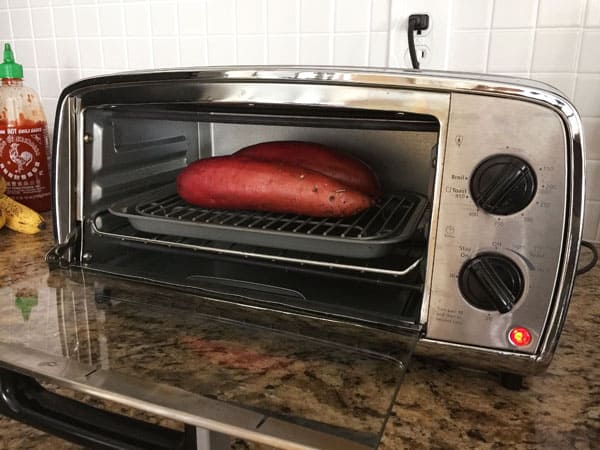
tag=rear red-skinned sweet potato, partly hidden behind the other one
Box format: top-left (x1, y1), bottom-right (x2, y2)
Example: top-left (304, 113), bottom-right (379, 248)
top-left (235, 141), bottom-right (380, 198)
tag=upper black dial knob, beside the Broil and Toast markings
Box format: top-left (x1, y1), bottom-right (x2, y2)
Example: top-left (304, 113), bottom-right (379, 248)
top-left (471, 155), bottom-right (536, 216)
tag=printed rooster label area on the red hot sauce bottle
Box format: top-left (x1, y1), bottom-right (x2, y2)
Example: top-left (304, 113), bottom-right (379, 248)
top-left (0, 123), bottom-right (50, 211)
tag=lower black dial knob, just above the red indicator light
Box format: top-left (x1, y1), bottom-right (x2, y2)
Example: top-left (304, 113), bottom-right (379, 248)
top-left (458, 253), bottom-right (524, 313)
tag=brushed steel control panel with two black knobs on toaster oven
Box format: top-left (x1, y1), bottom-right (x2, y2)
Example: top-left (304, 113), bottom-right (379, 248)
top-left (427, 94), bottom-right (567, 353)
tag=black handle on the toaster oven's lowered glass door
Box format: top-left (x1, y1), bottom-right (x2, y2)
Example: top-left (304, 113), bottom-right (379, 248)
top-left (0, 368), bottom-right (186, 450)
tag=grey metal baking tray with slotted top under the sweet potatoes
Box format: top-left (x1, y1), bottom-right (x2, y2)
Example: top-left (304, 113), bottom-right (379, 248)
top-left (109, 184), bottom-right (427, 258)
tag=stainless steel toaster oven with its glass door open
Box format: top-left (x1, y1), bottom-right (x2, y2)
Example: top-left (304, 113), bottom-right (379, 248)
top-left (0, 67), bottom-right (584, 448)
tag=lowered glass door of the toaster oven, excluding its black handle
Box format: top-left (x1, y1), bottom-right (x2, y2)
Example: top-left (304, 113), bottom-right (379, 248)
top-left (0, 269), bottom-right (420, 449)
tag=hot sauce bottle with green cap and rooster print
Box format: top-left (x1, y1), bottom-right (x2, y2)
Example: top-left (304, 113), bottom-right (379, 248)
top-left (0, 44), bottom-right (50, 212)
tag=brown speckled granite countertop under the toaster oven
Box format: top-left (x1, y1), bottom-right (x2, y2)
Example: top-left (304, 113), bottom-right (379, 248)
top-left (0, 217), bottom-right (600, 449)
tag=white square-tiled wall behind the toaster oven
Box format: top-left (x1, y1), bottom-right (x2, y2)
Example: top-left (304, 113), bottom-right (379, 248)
top-left (0, 0), bottom-right (600, 240)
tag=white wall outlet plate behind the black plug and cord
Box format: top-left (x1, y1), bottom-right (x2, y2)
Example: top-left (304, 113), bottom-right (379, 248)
top-left (388, 0), bottom-right (450, 70)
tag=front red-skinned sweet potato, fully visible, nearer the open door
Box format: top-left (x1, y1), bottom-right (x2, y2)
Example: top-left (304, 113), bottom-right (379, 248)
top-left (177, 156), bottom-right (373, 217)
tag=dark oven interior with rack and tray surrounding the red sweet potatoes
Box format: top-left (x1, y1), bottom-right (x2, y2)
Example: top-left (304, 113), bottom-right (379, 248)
top-left (79, 103), bottom-right (440, 328)
